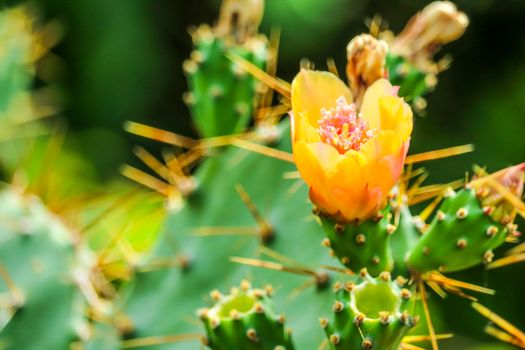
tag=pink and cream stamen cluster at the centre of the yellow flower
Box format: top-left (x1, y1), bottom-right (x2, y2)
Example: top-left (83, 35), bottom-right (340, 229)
top-left (317, 96), bottom-right (377, 154)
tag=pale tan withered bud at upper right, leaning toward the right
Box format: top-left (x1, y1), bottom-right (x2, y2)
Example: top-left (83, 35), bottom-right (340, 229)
top-left (392, 1), bottom-right (469, 73)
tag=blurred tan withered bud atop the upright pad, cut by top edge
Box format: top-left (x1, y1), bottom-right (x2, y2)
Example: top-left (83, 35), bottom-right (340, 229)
top-left (216, 0), bottom-right (264, 43)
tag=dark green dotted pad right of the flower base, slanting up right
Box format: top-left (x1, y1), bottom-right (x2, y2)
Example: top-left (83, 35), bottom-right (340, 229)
top-left (408, 189), bottom-right (507, 272)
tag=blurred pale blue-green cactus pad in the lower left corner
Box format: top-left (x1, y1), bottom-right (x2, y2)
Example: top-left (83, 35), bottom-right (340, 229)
top-left (0, 189), bottom-right (87, 350)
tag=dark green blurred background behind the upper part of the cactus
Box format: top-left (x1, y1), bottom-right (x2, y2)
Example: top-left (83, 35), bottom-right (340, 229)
top-left (18, 0), bottom-right (525, 181)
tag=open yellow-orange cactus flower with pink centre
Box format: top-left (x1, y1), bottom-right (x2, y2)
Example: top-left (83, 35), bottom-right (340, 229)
top-left (291, 69), bottom-right (412, 223)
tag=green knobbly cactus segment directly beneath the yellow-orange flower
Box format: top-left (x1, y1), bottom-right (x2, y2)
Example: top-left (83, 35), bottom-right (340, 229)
top-left (319, 209), bottom-right (395, 276)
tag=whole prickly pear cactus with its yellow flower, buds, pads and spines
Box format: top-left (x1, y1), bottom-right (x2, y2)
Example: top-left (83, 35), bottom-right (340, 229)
top-left (4, 0), bottom-right (525, 350)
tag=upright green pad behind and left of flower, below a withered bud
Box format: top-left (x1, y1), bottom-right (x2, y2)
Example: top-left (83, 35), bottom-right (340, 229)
top-left (184, 26), bottom-right (267, 137)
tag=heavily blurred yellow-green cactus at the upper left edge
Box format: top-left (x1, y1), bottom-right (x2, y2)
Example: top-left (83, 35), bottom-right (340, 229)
top-left (0, 5), bottom-right (56, 176)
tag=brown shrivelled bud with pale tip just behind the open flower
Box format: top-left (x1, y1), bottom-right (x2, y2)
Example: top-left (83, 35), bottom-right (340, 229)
top-left (346, 34), bottom-right (388, 109)
